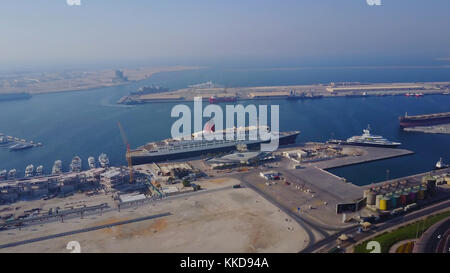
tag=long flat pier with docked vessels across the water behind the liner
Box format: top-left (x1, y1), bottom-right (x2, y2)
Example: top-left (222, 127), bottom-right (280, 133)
top-left (117, 79), bottom-right (450, 104)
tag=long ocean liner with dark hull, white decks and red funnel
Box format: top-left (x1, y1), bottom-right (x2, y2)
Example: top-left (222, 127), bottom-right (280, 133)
top-left (129, 125), bottom-right (300, 165)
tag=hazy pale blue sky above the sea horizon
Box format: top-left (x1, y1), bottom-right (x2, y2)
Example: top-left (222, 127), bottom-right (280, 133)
top-left (0, 0), bottom-right (450, 70)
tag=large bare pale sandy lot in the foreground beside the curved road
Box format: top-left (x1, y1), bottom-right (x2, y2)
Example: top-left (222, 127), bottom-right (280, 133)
top-left (0, 179), bottom-right (307, 252)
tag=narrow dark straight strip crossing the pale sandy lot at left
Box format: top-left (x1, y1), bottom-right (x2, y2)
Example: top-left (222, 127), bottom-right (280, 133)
top-left (0, 212), bottom-right (171, 249)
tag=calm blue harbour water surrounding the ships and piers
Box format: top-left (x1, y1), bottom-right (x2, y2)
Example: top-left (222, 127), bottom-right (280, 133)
top-left (0, 66), bottom-right (450, 184)
